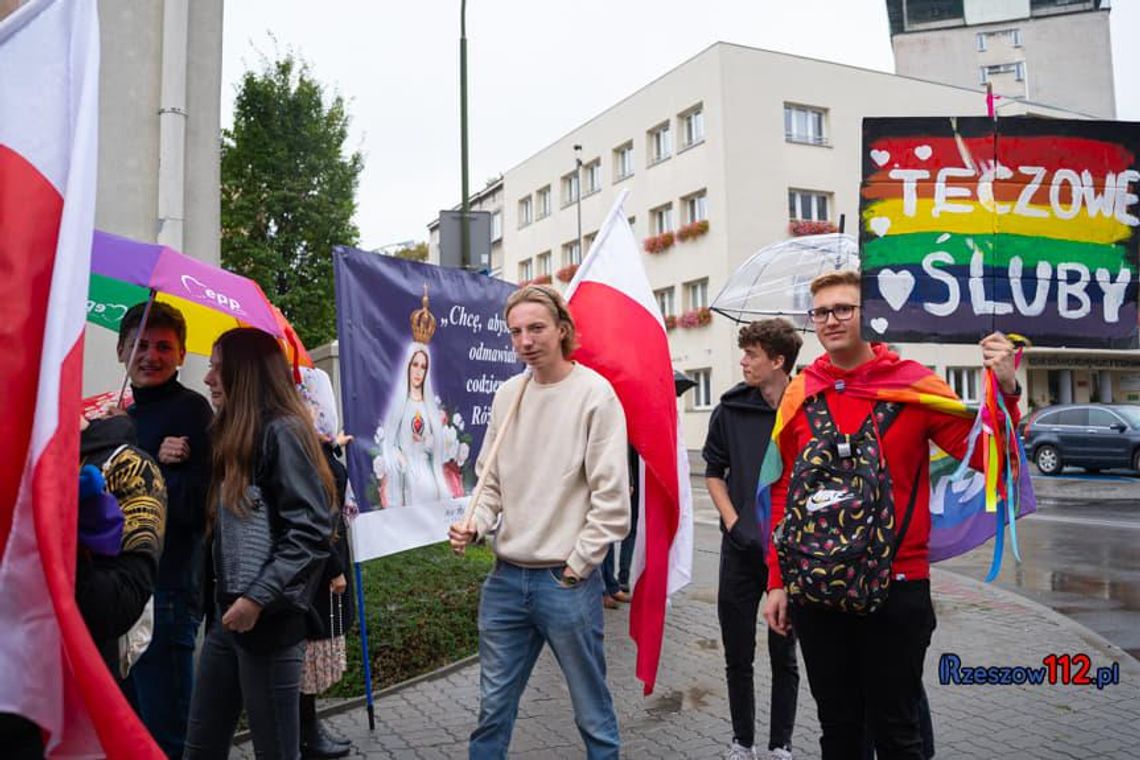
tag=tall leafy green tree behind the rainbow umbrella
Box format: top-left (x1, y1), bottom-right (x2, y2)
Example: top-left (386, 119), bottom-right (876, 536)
top-left (221, 55), bottom-right (364, 348)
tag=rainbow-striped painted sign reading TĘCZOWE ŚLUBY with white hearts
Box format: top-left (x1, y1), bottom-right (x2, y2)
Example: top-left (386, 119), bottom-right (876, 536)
top-left (860, 117), bottom-right (1140, 349)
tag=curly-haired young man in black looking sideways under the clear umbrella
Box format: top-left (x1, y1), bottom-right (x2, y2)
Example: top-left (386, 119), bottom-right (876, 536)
top-left (702, 318), bottom-right (804, 760)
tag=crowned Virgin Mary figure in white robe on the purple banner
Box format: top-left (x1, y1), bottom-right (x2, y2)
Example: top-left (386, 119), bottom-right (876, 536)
top-left (373, 285), bottom-right (463, 507)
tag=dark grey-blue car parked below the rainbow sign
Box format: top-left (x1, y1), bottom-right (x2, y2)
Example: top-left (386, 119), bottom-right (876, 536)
top-left (1023, 403), bottom-right (1140, 475)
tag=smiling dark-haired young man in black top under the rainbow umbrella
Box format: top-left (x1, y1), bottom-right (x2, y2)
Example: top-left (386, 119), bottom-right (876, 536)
top-left (119, 302), bottom-right (213, 758)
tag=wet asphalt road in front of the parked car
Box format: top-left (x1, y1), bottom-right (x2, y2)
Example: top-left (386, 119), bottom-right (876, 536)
top-left (938, 474), bottom-right (1140, 659)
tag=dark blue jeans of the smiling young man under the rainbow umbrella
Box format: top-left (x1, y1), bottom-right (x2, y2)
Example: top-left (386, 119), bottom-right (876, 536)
top-left (123, 589), bottom-right (202, 758)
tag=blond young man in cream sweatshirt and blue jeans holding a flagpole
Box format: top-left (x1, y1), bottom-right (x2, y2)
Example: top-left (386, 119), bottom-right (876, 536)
top-left (448, 285), bottom-right (629, 760)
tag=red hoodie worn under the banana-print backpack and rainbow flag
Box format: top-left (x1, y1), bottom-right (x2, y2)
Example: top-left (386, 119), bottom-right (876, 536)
top-left (768, 343), bottom-right (1020, 591)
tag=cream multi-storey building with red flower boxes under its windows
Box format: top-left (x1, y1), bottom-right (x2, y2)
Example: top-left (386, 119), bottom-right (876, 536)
top-left (449, 42), bottom-right (1108, 449)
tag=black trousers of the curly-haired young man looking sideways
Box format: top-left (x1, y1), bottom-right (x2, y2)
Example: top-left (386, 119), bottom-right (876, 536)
top-left (717, 534), bottom-right (799, 750)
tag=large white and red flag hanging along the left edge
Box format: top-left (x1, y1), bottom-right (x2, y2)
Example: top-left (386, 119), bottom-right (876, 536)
top-left (0, 0), bottom-right (162, 758)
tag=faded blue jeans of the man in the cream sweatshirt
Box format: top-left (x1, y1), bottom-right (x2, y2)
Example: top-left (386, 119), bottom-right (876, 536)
top-left (470, 561), bottom-right (619, 760)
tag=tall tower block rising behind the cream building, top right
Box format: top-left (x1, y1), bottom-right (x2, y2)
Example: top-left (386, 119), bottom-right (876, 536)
top-left (887, 0), bottom-right (1116, 119)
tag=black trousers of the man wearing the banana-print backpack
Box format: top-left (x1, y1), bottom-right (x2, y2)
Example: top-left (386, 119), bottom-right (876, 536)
top-left (789, 580), bottom-right (936, 760)
